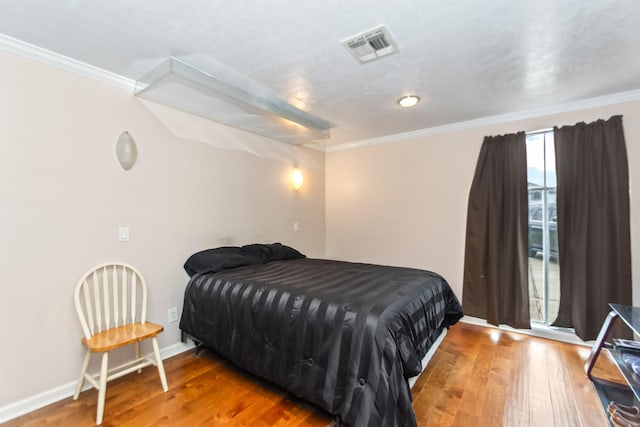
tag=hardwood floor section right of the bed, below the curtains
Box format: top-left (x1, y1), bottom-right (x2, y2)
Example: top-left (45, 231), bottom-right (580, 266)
top-left (413, 324), bottom-right (624, 427)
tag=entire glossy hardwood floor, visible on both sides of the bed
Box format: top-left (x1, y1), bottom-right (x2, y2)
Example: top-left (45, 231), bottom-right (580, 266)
top-left (4, 323), bottom-right (623, 427)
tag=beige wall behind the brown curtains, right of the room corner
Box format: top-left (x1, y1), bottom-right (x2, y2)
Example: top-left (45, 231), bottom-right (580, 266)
top-left (326, 102), bottom-right (640, 303)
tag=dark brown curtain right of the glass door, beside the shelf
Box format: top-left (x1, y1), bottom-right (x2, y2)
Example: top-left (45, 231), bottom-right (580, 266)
top-left (554, 116), bottom-right (632, 340)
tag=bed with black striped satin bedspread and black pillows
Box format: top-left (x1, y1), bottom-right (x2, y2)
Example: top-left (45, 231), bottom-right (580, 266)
top-left (180, 243), bottom-right (462, 427)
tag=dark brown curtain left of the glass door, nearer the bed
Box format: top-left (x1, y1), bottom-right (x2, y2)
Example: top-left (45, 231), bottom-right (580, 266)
top-left (462, 132), bottom-right (530, 329)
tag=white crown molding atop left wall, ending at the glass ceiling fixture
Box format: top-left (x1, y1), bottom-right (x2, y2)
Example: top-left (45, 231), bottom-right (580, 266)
top-left (0, 34), bottom-right (135, 92)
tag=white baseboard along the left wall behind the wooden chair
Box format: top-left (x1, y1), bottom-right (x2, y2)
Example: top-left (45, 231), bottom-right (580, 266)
top-left (0, 342), bottom-right (194, 424)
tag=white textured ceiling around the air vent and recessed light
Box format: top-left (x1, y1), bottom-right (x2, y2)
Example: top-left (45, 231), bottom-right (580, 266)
top-left (0, 0), bottom-right (640, 145)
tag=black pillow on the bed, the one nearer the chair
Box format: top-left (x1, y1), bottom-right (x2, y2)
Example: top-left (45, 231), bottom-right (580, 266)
top-left (184, 246), bottom-right (263, 276)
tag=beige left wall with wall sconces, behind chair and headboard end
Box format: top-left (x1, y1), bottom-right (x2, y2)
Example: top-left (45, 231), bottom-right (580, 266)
top-left (0, 52), bottom-right (325, 407)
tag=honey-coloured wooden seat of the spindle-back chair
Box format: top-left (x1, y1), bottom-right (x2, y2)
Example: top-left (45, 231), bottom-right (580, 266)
top-left (82, 322), bottom-right (164, 353)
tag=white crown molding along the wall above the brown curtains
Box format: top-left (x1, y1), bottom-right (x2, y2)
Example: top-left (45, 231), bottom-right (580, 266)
top-left (328, 89), bottom-right (640, 153)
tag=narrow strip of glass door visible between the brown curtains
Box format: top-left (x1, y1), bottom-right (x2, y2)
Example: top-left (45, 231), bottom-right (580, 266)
top-left (527, 130), bottom-right (560, 325)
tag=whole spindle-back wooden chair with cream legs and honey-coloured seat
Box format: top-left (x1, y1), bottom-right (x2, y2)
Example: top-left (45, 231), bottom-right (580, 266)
top-left (73, 263), bottom-right (168, 425)
